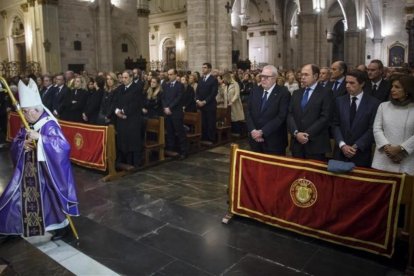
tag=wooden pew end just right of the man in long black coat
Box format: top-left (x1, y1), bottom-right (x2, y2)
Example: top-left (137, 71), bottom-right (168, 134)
top-left (144, 116), bottom-right (165, 166)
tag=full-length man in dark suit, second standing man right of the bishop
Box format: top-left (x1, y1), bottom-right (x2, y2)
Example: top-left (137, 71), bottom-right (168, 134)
top-left (161, 69), bottom-right (187, 160)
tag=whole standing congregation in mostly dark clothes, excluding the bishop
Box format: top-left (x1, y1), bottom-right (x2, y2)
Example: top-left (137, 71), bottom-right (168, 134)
top-left (0, 60), bottom-right (414, 174)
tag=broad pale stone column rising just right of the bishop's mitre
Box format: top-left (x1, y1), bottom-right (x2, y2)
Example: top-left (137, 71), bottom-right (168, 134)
top-left (37, 0), bottom-right (63, 73)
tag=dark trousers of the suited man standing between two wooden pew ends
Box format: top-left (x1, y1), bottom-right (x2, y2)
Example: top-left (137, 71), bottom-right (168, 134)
top-left (165, 116), bottom-right (188, 155)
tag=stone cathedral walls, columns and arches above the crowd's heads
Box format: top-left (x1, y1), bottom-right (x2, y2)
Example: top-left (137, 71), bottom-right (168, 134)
top-left (0, 0), bottom-right (414, 76)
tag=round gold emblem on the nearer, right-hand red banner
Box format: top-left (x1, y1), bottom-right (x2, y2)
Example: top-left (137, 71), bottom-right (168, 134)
top-left (290, 178), bottom-right (318, 208)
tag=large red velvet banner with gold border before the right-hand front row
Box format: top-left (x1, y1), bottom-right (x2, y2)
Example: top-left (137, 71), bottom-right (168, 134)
top-left (230, 150), bottom-right (404, 257)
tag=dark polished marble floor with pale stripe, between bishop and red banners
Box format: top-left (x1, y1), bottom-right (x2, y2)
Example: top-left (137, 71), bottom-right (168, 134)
top-left (0, 141), bottom-right (407, 276)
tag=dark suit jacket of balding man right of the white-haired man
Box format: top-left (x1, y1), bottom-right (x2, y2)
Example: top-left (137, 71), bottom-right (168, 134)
top-left (288, 84), bottom-right (333, 154)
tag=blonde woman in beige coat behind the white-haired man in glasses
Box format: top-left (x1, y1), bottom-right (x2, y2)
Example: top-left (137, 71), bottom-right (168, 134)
top-left (223, 73), bottom-right (244, 135)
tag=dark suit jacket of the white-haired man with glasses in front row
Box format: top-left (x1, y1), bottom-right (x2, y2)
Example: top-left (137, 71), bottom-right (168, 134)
top-left (246, 85), bottom-right (290, 151)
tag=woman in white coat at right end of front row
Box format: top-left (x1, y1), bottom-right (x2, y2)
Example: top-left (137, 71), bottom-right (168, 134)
top-left (372, 75), bottom-right (414, 175)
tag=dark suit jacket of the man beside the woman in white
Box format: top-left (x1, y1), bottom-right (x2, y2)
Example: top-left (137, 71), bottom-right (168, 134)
top-left (332, 93), bottom-right (381, 167)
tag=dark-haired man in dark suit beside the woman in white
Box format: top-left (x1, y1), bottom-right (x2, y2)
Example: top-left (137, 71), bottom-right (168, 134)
top-left (332, 70), bottom-right (380, 167)
